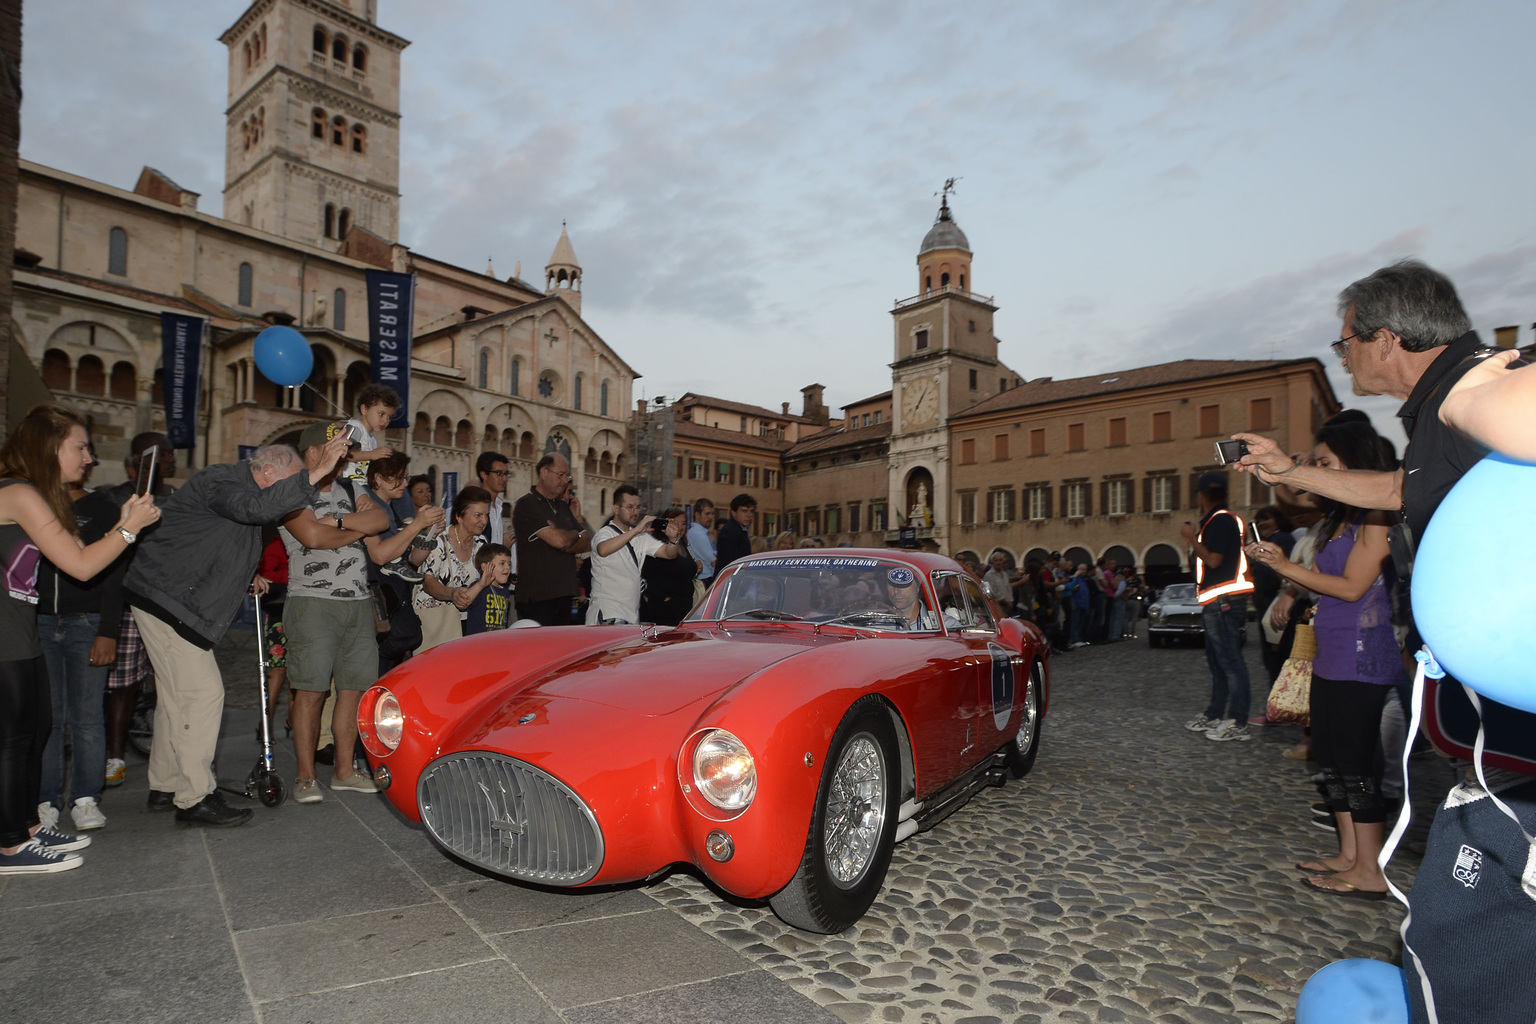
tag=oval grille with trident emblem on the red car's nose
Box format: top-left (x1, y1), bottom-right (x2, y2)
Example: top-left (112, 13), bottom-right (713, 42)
top-left (416, 751), bottom-right (602, 886)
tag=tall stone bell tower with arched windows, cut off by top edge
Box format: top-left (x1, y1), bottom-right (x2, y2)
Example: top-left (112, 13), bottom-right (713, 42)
top-left (220, 0), bottom-right (410, 250)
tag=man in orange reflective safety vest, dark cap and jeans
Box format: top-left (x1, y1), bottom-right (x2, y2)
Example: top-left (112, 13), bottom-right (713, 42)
top-left (1180, 473), bottom-right (1253, 742)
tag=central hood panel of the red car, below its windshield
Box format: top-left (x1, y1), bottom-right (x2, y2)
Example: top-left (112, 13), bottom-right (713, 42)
top-left (503, 626), bottom-right (849, 717)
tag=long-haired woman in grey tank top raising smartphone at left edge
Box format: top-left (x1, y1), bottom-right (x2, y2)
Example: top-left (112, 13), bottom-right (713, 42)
top-left (0, 405), bottom-right (160, 875)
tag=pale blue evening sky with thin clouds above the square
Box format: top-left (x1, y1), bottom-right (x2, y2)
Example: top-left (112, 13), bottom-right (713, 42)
top-left (22, 0), bottom-right (1536, 444)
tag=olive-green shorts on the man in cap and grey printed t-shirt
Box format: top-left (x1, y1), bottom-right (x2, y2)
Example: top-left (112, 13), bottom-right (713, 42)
top-left (283, 594), bottom-right (379, 692)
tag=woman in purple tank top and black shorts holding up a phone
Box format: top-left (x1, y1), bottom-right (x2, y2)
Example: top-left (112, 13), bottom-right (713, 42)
top-left (1247, 421), bottom-right (1402, 900)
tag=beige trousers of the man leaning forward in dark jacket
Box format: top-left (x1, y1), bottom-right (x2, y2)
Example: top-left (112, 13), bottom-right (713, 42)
top-left (134, 608), bottom-right (224, 809)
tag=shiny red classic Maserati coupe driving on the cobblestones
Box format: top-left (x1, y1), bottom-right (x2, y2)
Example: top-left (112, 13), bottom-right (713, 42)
top-left (358, 548), bottom-right (1049, 932)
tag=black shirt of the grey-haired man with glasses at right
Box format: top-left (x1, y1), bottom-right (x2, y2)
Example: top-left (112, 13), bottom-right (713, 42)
top-left (1398, 332), bottom-right (1488, 543)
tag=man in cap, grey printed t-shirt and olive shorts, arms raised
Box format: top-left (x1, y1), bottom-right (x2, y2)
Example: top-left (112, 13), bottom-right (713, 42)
top-left (278, 424), bottom-right (389, 803)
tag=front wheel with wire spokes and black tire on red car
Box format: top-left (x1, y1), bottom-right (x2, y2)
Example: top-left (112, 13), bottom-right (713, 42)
top-left (768, 697), bottom-right (902, 935)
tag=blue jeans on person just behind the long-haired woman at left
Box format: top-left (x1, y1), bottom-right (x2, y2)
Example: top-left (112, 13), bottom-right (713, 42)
top-left (37, 613), bottom-right (109, 809)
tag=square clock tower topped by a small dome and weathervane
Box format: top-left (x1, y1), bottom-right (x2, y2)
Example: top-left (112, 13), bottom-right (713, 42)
top-left (889, 187), bottom-right (1011, 551)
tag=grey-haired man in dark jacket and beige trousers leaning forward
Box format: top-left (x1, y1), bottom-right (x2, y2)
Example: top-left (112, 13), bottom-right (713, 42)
top-left (124, 431), bottom-right (350, 826)
